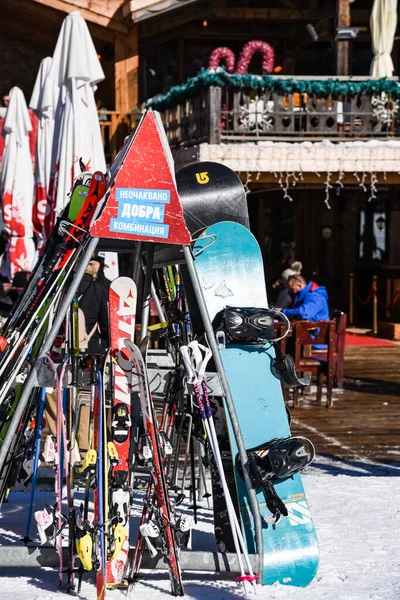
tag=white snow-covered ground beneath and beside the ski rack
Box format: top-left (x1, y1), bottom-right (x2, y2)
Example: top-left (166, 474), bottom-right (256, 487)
top-left (0, 457), bottom-right (400, 600)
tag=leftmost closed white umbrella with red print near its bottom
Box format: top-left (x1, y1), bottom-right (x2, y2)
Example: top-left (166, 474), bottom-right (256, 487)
top-left (0, 87), bottom-right (36, 280)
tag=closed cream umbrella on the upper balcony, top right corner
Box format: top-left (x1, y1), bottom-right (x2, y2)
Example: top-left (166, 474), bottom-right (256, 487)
top-left (370, 0), bottom-right (397, 77)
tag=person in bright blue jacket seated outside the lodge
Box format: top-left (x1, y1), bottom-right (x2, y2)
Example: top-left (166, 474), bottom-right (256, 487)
top-left (282, 275), bottom-right (329, 321)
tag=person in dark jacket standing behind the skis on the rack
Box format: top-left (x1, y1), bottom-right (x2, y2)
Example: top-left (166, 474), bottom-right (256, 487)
top-left (77, 254), bottom-right (111, 354)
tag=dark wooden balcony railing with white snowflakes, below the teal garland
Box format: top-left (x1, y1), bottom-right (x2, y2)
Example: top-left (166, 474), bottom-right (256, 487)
top-left (154, 77), bottom-right (400, 146)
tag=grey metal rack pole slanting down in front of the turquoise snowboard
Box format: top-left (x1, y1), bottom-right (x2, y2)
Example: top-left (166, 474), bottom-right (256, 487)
top-left (182, 246), bottom-right (264, 572)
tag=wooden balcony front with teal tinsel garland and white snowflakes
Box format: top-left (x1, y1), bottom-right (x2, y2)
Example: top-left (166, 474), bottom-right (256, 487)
top-left (148, 71), bottom-right (400, 147)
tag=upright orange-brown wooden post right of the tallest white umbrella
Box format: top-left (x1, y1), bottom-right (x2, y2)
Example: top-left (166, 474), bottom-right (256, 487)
top-left (114, 24), bottom-right (139, 115)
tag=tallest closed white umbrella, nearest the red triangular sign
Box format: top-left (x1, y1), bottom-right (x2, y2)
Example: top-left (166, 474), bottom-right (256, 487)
top-left (44, 11), bottom-right (106, 238)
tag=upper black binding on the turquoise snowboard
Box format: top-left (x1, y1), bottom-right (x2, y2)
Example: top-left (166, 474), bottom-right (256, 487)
top-left (213, 306), bottom-right (290, 345)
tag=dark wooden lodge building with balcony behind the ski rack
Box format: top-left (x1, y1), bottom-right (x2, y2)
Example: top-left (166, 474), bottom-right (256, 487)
top-left (0, 0), bottom-right (400, 323)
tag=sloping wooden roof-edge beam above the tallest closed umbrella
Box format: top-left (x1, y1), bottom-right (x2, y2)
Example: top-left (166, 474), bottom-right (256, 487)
top-left (33, 0), bottom-right (128, 34)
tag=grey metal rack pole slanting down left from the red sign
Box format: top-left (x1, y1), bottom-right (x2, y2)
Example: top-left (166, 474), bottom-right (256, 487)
top-left (0, 238), bottom-right (99, 471)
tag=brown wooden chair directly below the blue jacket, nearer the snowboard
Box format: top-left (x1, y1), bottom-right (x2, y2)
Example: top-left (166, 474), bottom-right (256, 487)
top-left (293, 321), bottom-right (338, 407)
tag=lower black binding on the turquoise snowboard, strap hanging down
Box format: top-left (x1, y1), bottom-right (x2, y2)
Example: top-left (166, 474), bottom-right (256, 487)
top-left (236, 437), bottom-right (315, 525)
